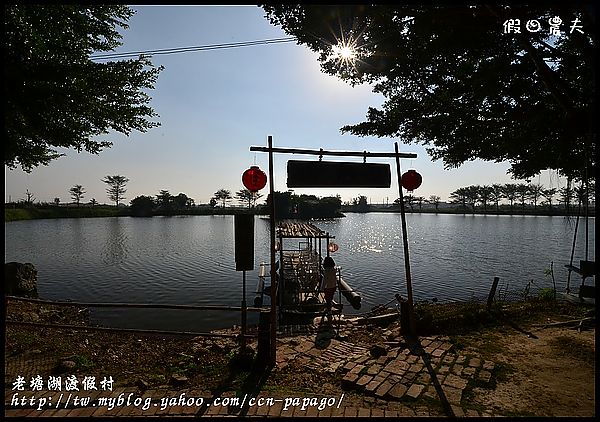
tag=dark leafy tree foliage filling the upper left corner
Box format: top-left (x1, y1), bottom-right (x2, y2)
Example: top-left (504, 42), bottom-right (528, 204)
top-left (3, 4), bottom-right (162, 172)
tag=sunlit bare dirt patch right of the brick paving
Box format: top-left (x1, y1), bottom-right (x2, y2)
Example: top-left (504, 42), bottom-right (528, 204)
top-left (458, 320), bottom-right (596, 417)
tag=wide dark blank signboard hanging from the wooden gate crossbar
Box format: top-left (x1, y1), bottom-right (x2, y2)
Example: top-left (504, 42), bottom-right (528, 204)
top-left (287, 160), bottom-right (391, 188)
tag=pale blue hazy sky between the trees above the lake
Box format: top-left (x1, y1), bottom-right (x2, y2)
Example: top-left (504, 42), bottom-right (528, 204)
top-left (5, 5), bottom-right (564, 204)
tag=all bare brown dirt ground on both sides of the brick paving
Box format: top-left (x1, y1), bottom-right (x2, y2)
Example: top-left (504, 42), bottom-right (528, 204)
top-left (5, 298), bottom-right (596, 417)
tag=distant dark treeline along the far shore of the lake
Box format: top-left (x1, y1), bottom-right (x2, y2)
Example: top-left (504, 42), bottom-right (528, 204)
top-left (4, 183), bottom-right (595, 221)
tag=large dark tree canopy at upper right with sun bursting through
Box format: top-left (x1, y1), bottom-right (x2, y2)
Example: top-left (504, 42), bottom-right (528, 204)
top-left (262, 2), bottom-right (596, 179)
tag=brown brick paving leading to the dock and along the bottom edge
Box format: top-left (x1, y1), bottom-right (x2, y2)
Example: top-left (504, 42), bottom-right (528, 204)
top-left (5, 326), bottom-right (494, 418)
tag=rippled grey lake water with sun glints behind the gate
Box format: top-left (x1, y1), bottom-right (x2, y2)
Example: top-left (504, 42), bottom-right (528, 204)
top-left (5, 213), bottom-right (595, 331)
